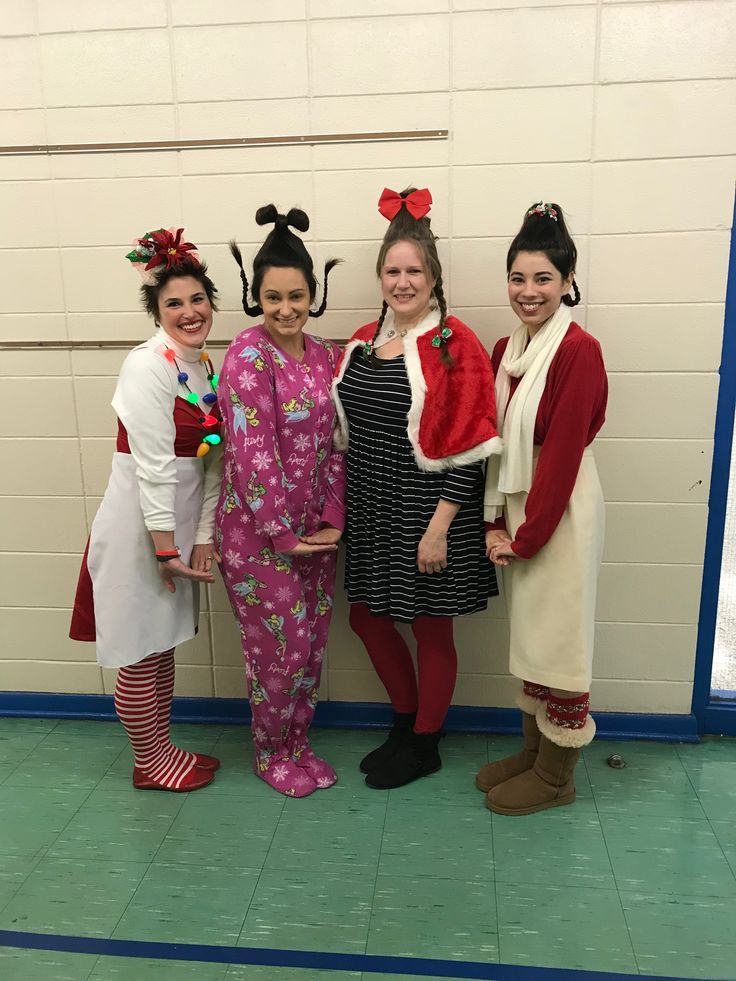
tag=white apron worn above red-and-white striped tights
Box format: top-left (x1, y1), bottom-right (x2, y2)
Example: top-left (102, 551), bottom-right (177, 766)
top-left (87, 453), bottom-right (203, 668)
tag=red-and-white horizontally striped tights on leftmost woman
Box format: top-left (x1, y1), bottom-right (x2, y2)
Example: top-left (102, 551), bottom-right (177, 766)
top-left (115, 649), bottom-right (196, 790)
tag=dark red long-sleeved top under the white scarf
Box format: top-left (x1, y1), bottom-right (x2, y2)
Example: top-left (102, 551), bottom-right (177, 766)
top-left (486, 322), bottom-right (608, 559)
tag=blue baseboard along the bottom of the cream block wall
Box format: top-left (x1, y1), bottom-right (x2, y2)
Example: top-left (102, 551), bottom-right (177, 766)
top-left (0, 691), bottom-right (698, 743)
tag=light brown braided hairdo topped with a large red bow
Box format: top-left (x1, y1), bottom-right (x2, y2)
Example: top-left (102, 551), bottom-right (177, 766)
top-left (364, 187), bottom-right (455, 366)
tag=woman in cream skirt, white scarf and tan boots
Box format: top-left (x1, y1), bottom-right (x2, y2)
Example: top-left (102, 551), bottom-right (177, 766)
top-left (476, 202), bottom-right (608, 814)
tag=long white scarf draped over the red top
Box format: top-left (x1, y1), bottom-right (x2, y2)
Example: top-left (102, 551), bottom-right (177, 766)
top-left (484, 303), bottom-right (572, 521)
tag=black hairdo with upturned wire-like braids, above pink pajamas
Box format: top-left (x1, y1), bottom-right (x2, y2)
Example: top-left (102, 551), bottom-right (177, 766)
top-left (230, 204), bottom-right (342, 317)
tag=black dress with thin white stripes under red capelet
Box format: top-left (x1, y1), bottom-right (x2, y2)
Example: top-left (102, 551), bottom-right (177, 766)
top-left (338, 353), bottom-right (498, 621)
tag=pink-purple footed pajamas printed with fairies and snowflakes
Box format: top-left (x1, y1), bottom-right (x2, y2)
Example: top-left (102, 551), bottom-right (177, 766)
top-left (217, 326), bottom-right (345, 797)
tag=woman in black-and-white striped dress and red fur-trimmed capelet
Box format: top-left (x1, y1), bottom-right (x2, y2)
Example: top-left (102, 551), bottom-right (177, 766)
top-left (333, 189), bottom-right (500, 789)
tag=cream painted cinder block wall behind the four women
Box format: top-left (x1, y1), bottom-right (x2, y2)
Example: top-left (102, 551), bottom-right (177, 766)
top-left (0, 0), bottom-right (736, 713)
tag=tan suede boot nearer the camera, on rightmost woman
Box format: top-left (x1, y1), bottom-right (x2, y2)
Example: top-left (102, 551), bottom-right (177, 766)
top-left (486, 735), bottom-right (580, 814)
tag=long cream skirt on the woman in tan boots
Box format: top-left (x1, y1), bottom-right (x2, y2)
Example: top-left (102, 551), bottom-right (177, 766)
top-left (503, 446), bottom-right (605, 692)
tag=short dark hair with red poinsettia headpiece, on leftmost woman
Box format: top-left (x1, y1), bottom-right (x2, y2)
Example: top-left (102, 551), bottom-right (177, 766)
top-left (125, 228), bottom-right (217, 320)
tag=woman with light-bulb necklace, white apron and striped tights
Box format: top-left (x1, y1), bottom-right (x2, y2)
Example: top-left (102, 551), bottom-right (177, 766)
top-left (70, 229), bottom-right (222, 791)
